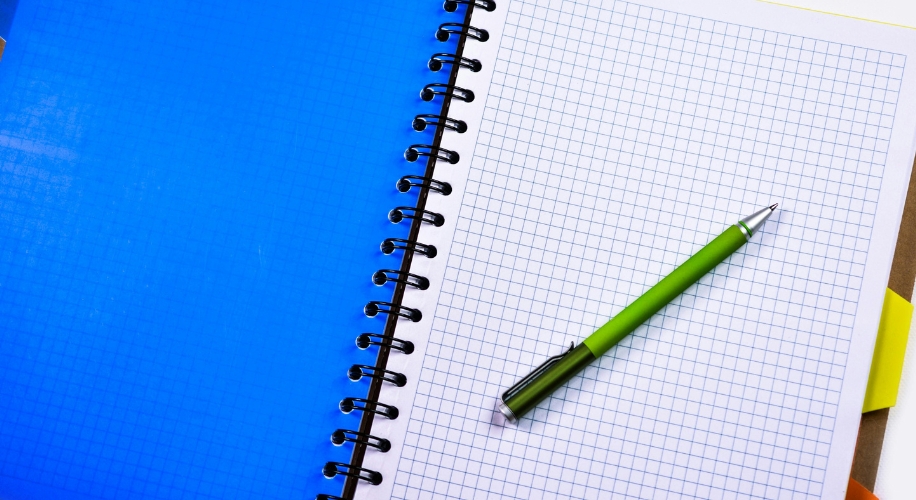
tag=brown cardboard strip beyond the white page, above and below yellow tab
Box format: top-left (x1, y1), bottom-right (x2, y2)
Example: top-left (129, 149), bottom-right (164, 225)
top-left (849, 153), bottom-right (916, 491)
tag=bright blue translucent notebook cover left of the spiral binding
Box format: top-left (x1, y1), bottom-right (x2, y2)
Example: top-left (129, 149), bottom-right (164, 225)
top-left (0, 0), bottom-right (461, 499)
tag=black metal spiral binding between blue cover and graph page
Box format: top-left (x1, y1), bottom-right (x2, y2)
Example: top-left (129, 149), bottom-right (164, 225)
top-left (316, 0), bottom-right (496, 500)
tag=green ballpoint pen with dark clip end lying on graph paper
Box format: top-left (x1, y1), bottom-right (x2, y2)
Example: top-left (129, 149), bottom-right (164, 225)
top-left (498, 204), bottom-right (778, 423)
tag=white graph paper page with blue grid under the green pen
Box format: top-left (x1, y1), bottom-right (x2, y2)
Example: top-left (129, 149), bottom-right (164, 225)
top-left (360, 0), bottom-right (914, 499)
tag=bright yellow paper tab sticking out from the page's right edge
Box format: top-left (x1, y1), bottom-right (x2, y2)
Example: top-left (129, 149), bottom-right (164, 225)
top-left (862, 288), bottom-right (913, 413)
